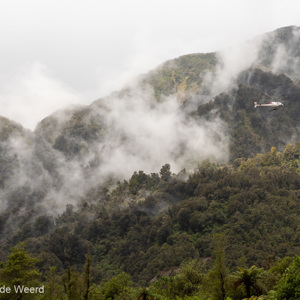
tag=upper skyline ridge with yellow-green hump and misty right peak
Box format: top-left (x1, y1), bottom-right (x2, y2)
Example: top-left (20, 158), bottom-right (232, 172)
top-left (143, 26), bottom-right (300, 100)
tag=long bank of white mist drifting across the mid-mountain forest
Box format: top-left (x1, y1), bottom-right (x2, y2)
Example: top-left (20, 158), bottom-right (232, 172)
top-left (0, 81), bottom-right (229, 221)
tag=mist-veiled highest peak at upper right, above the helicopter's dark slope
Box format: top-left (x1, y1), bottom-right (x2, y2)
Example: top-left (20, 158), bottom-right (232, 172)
top-left (204, 26), bottom-right (300, 104)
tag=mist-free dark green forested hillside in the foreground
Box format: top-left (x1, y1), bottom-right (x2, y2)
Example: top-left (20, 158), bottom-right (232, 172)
top-left (0, 143), bottom-right (300, 299)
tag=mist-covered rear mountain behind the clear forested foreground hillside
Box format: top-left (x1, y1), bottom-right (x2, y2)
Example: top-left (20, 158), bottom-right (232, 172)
top-left (0, 27), bottom-right (300, 248)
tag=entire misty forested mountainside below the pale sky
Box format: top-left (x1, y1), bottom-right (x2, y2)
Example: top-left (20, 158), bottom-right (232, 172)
top-left (0, 27), bottom-right (300, 300)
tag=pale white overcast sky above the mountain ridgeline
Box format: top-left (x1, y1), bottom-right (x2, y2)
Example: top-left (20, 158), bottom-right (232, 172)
top-left (0, 0), bottom-right (300, 129)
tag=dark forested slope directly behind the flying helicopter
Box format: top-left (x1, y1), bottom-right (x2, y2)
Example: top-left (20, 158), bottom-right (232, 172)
top-left (196, 68), bottom-right (300, 160)
